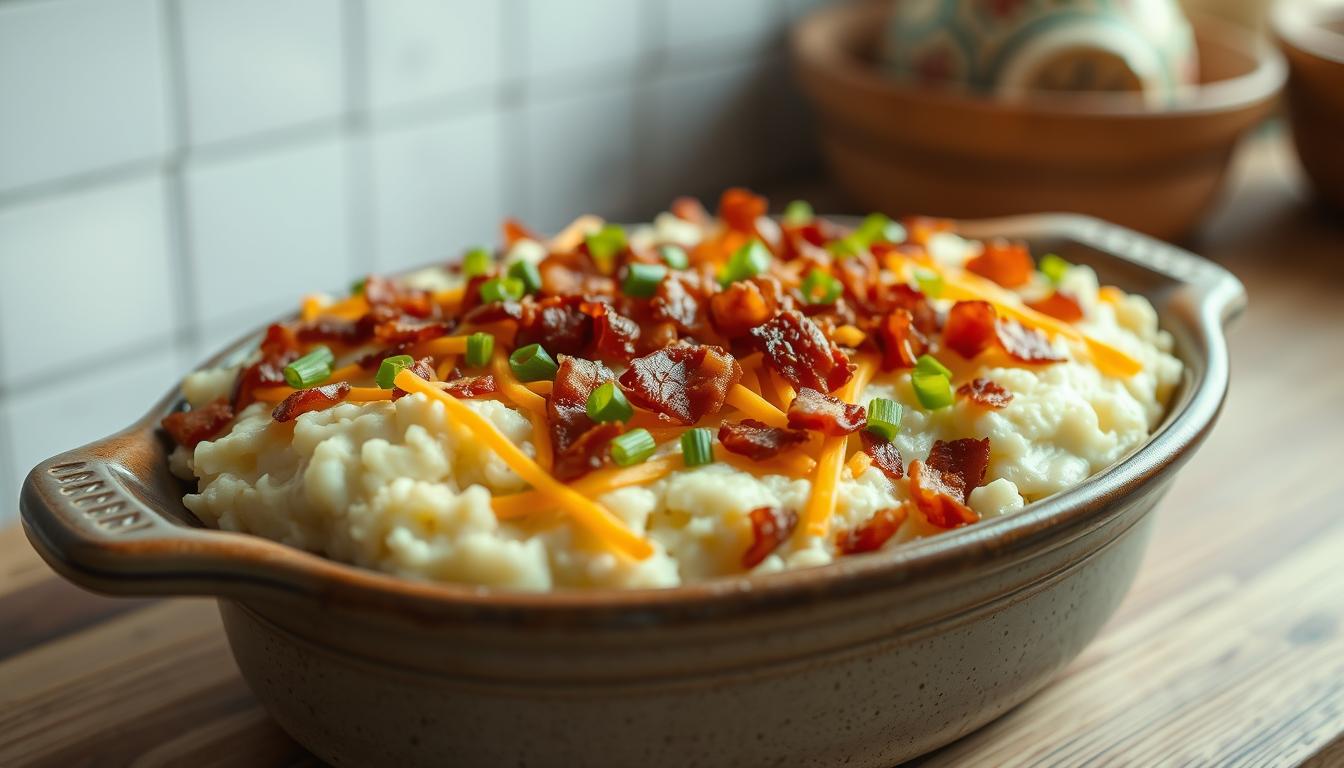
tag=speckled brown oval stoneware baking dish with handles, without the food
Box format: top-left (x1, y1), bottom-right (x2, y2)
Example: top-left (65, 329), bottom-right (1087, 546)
top-left (22, 215), bottom-right (1245, 768)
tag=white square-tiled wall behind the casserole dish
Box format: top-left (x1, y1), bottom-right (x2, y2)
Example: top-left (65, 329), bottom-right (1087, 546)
top-left (0, 0), bottom-right (1317, 525)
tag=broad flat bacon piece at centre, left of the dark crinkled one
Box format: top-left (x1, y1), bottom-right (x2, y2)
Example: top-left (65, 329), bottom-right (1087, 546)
top-left (620, 344), bottom-right (742, 424)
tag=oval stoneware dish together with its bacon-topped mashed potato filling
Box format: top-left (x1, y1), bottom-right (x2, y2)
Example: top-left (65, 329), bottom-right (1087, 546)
top-left (22, 191), bottom-right (1242, 767)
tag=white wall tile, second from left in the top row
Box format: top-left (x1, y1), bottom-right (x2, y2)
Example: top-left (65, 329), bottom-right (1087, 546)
top-left (181, 0), bottom-right (345, 143)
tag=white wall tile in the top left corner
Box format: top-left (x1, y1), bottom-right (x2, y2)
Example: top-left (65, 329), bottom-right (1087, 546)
top-left (0, 0), bottom-right (168, 191)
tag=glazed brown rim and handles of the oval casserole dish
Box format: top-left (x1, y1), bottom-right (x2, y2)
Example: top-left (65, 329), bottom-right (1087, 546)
top-left (20, 214), bottom-right (1245, 625)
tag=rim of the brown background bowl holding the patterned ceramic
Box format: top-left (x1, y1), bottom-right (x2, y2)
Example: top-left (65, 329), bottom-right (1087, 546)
top-left (790, 0), bottom-right (1288, 120)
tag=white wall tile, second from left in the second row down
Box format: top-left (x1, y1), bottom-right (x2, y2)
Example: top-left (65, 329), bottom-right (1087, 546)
top-left (187, 139), bottom-right (356, 328)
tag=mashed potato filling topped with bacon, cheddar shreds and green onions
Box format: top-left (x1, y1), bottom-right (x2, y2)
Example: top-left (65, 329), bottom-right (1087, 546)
top-left (163, 190), bottom-right (1180, 590)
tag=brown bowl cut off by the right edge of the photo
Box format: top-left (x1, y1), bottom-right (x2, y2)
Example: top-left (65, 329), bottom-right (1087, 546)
top-left (1270, 0), bottom-right (1344, 210)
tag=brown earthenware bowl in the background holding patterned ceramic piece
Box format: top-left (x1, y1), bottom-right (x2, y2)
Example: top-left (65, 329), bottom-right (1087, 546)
top-left (793, 1), bottom-right (1286, 239)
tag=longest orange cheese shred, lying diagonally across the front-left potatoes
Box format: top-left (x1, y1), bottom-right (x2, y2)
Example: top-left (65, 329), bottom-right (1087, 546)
top-left (395, 370), bottom-right (653, 560)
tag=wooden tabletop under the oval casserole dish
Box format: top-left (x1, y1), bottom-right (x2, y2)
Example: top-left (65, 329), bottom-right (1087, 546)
top-left (0, 135), bottom-right (1344, 767)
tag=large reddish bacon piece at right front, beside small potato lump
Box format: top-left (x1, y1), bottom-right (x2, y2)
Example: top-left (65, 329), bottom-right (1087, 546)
top-left (910, 437), bottom-right (989, 529)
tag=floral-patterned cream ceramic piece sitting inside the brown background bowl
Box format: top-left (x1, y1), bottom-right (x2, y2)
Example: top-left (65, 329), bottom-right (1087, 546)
top-left (883, 0), bottom-right (1196, 104)
